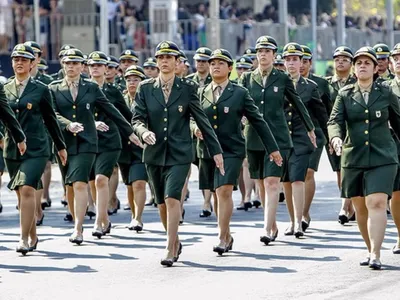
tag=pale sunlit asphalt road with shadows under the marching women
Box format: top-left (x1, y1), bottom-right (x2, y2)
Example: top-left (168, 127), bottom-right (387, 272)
top-left (0, 152), bottom-right (400, 300)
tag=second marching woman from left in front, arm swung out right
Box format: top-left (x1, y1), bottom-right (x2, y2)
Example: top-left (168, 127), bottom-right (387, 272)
top-left (49, 49), bottom-right (139, 245)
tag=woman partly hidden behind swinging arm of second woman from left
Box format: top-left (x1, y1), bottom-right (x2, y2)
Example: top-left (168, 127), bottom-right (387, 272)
top-left (88, 51), bottom-right (132, 238)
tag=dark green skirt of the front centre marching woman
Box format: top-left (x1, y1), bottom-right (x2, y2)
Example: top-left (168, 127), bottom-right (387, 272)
top-left (146, 164), bottom-right (191, 204)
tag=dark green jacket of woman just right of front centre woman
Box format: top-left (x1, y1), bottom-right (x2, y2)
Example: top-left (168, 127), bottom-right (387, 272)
top-left (197, 82), bottom-right (279, 158)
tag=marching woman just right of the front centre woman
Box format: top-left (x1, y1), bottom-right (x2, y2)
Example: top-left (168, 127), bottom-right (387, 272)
top-left (195, 49), bottom-right (282, 255)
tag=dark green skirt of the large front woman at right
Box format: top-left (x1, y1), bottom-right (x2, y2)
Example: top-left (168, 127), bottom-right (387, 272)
top-left (341, 164), bottom-right (398, 199)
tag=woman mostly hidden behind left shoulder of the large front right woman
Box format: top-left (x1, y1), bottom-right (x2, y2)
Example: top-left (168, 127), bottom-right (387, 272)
top-left (326, 46), bottom-right (356, 225)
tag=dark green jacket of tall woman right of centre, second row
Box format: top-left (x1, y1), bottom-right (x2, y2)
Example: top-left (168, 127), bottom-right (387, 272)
top-left (239, 68), bottom-right (314, 151)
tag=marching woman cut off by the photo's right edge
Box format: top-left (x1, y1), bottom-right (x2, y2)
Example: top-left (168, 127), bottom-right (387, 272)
top-left (388, 43), bottom-right (400, 254)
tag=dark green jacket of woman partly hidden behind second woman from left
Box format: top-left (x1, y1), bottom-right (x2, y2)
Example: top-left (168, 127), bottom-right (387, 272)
top-left (94, 83), bottom-right (132, 153)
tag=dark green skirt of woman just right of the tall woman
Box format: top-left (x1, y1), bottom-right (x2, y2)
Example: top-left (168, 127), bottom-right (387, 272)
top-left (282, 151), bottom-right (311, 182)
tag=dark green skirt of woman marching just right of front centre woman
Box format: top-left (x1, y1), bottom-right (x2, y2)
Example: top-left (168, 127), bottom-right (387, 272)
top-left (199, 157), bottom-right (243, 192)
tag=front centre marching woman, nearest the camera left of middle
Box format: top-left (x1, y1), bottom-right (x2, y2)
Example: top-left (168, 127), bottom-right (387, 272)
top-left (132, 41), bottom-right (224, 266)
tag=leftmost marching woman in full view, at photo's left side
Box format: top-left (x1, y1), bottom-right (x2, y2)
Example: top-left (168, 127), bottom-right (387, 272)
top-left (4, 44), bottom-right (67, 255)
